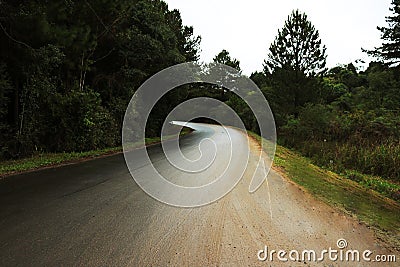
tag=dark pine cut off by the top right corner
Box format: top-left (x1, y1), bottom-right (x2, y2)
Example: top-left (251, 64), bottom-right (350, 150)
top-left (363, 0), bottom-right (400, 65)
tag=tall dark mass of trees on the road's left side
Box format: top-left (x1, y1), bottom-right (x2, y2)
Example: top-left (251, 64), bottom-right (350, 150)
top-left (0, 0), bottom-right (200, 158)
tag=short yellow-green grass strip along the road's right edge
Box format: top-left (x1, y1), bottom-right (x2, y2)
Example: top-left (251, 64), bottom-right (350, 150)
top-left (250, 133), bottom-right (400, 248)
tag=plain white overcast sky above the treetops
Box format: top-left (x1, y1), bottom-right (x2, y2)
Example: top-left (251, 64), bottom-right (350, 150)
top-left (165, 0), bottom-right (391, 75)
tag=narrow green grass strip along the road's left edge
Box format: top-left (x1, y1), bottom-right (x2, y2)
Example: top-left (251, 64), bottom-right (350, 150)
top-left (0, 128), bottom-right (191, 177)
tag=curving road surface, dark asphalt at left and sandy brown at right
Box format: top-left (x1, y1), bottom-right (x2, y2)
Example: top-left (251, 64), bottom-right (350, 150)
top-left (0, 126), bottom-right (396, 266)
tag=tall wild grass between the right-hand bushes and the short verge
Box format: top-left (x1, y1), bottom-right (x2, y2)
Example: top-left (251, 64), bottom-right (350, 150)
top-left (282, 140), bottom-right (400, 203)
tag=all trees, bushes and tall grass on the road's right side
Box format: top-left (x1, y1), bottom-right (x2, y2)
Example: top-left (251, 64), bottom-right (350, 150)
top-left (217, 5), bottom-right (400, 201)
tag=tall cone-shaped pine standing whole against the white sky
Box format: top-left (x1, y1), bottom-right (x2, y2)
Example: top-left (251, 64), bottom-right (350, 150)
top-left (264, 10), bottom-right (326, 118)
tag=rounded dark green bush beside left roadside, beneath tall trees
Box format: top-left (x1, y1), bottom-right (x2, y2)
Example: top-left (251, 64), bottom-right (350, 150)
top-left (47, 90), bottom-right (120, 152)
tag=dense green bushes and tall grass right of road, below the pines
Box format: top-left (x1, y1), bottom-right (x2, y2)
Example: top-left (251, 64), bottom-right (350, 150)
top-left (264, 63), bottom-right (400, 184)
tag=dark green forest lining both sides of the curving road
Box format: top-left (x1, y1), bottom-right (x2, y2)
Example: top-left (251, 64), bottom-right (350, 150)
top-left (0, 0), bottom-right (400, 200)
